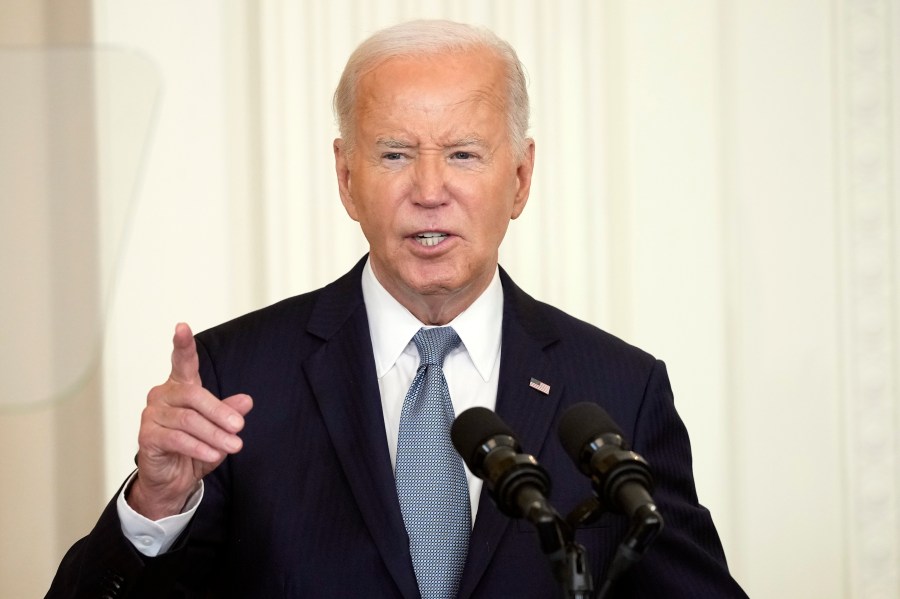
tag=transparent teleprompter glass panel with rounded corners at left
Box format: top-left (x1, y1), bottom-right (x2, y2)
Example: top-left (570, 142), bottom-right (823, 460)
top-left (0, 47), bottom-right (160, 409)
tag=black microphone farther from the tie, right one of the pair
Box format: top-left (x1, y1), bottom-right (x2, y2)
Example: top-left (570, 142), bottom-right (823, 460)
top-left (559, 402), bottom-right (663, 549)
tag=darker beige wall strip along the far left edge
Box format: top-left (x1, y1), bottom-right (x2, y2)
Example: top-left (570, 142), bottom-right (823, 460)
top-left (0, 0), bottom-right (105, 597)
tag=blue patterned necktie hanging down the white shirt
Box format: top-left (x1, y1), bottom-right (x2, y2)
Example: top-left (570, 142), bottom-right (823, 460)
top-left (397, 327), bottom-right (472, 599)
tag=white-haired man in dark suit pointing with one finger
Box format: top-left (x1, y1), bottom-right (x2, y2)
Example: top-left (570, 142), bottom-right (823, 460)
top-left (48, 21), bottom-right (744, 598)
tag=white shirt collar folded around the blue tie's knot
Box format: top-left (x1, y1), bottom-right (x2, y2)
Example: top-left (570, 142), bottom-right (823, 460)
top-left (362, 260), bottom-right (503, 381)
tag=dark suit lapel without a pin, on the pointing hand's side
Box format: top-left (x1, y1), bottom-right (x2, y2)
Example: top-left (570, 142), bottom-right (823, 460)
top-left (303, 261), bottom-right (419, 598)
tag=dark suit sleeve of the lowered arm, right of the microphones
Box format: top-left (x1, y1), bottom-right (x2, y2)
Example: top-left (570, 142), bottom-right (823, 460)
top-left (614, 361), bottom-right (747, 599)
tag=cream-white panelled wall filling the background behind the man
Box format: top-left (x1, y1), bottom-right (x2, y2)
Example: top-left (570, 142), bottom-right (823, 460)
top-left (0, 0), bottom-right (900, 599)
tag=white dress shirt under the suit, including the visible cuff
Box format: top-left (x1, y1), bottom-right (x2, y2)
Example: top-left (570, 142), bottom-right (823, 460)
top-left (116, 262), bottom-right (503, 557)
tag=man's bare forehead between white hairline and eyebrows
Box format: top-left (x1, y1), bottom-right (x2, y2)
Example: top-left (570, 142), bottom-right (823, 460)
top-left (355, 50), bottom-right (506, 137)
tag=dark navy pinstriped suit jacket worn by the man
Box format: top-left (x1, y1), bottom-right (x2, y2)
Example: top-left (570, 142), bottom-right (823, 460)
top-left (48, 261), bottom-right (745, 599)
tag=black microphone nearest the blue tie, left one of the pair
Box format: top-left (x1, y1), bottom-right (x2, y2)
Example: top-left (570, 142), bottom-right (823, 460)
top-left (450, 408), bottom-right (559, 524)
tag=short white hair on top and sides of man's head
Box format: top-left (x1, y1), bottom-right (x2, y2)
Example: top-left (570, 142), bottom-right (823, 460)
top-left (334, 20), bottom-right (529, 158)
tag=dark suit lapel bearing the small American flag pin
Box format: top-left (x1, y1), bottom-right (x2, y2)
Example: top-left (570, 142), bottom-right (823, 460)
top-left (459, 268), bottom-right (563, 598)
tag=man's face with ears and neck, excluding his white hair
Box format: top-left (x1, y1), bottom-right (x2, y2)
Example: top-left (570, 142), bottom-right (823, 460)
top-left (334, 51), bottom-right (534, 324)
